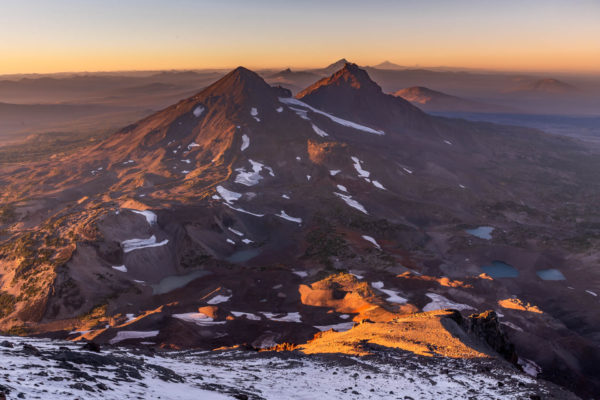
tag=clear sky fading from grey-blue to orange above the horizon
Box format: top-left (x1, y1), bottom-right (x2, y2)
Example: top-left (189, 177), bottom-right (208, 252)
top-left (0, 0), bottom-right (600, 74)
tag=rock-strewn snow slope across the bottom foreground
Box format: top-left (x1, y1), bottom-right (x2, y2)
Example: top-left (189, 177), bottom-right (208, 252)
top-left (0, 334), bottom-right (576, 400)
